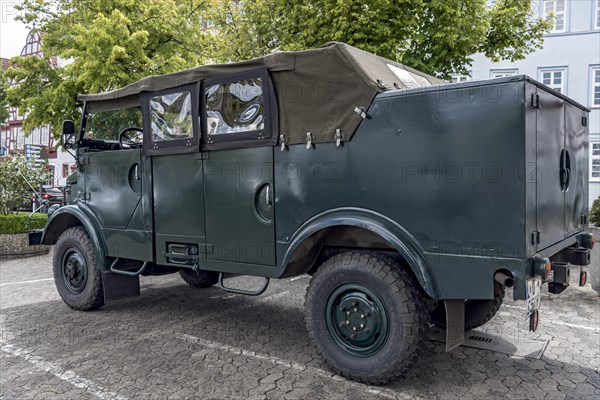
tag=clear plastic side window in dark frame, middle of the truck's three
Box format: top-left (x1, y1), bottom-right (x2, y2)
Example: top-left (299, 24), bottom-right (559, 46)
top-left (142, 83), bottom-right (200, 155)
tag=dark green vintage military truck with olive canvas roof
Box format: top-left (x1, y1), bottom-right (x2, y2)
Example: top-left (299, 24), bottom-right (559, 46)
top-left (30, 43), bottom-right (594, 383)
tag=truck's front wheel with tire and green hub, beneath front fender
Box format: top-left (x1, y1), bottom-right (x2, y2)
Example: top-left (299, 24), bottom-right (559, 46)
top-left (53, 226), bottom-right (104, 311)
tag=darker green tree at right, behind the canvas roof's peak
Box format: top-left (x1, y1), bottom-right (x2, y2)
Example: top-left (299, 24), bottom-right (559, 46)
top-left (210, 0), bottom-right (551, 78)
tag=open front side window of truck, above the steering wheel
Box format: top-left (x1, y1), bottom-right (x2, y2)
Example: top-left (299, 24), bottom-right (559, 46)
top-left (83, 107), bottom-right (142, 141)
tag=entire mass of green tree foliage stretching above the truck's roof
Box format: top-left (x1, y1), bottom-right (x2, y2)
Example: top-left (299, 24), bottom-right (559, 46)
top-left (5, 0), bottom-right (551, 135)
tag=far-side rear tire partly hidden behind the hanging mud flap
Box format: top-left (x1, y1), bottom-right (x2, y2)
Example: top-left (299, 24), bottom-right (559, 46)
top-left (431, 282), bottom-right (505, 331)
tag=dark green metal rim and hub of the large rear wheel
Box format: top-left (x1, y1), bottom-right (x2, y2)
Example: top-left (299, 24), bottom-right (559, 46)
top-left (327, 284), bottom-right (388, 356)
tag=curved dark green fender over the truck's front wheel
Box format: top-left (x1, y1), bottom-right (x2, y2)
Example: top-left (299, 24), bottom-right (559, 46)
top-left (41, 205), bottom-right (109, 270)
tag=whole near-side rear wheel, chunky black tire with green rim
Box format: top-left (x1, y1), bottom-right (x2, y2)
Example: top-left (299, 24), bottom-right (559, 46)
top-left (305, 251), bottom-right (428, 384)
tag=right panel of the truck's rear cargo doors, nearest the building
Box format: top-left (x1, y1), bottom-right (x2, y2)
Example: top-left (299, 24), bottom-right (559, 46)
top-left (564, 103), bottom-right (588, 237)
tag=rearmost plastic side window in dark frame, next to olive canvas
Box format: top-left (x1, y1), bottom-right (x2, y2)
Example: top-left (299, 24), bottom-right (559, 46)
top-left (201, 70), bottom-right (277, 149)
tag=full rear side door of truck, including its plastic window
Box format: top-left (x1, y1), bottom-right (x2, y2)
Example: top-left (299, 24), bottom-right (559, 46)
top-left (200, 70), bottom-right (277, 265)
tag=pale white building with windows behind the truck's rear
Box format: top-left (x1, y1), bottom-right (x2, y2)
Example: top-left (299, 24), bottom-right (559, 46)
top-left (454, 0), bottom-right (600, 206)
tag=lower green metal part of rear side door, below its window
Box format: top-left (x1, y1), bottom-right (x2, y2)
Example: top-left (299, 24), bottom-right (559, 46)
top-left (204, 147), bottom-right (275, 265)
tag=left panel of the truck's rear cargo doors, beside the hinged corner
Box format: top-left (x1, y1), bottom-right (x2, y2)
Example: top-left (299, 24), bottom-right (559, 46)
top-left (531, 88), bottom-right (565, 250)
